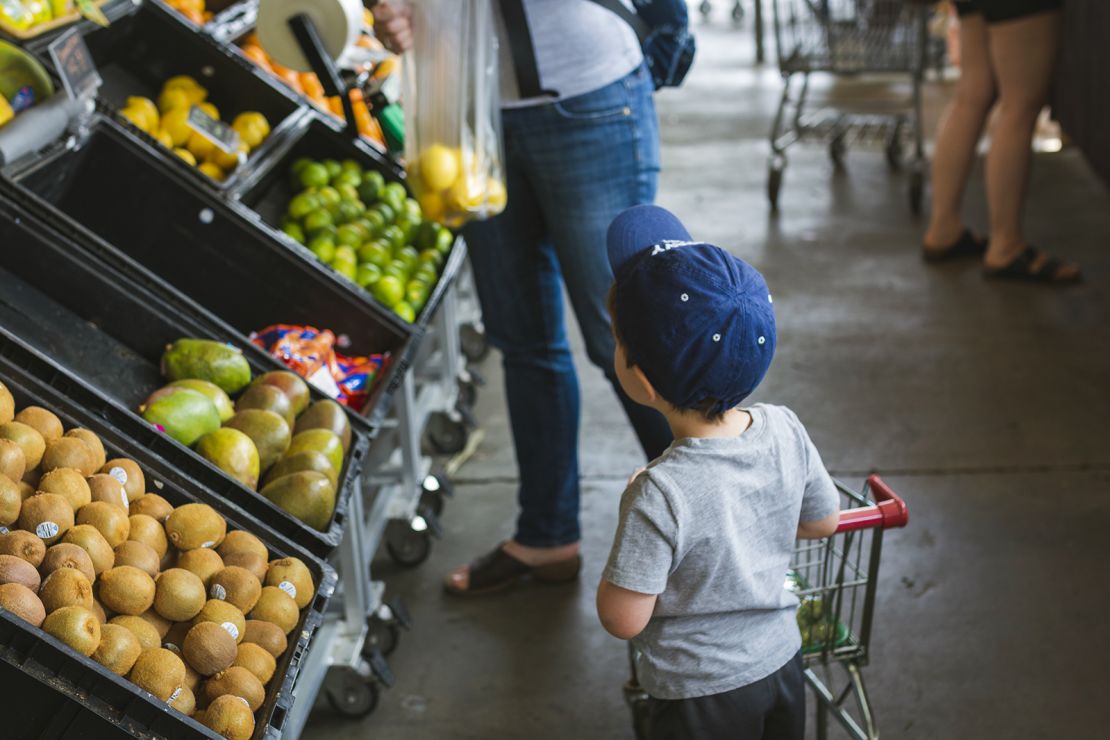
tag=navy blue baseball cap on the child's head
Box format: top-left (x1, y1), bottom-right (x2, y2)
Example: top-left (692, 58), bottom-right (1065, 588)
top-left (608, 205), bottom-right (775, 414)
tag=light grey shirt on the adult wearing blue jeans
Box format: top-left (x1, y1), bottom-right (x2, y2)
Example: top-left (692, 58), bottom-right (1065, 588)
top-left (493, 0), bottom-right (644, 108)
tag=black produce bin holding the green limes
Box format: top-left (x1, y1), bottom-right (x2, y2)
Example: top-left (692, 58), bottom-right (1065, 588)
top-left (236, 114), bottom-right (466, 330)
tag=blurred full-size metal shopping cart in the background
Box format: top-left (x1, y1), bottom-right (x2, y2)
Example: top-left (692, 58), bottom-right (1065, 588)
top-left (767, 0), bottom-right (928, 214)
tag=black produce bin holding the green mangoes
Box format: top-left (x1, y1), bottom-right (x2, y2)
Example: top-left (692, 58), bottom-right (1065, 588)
top-left (0, 190), bottom-right (369, 557)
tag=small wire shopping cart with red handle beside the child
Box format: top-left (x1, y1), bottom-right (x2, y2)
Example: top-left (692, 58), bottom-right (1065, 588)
top-left (624, 475), bottom-right (909, 740)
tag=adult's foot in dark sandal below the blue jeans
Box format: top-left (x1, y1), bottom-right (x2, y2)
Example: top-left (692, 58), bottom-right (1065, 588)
top-left (443, 540), bottom-right (582, 596)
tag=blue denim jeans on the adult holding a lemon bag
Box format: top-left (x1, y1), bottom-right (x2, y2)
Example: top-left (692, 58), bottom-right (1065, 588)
top-left (464, 68), bottom-right (670, 547)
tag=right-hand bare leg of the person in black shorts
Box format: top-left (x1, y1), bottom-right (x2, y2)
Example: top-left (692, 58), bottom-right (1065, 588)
top-left (985, 12), bottom-right (1079, 277)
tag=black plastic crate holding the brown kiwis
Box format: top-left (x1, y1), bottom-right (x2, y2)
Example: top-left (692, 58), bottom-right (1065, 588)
top-left (0, 334), bottom-right (336, 739)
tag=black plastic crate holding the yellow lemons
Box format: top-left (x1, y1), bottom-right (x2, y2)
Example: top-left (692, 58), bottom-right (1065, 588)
top-left (36, 2), bottom-right (305, 190)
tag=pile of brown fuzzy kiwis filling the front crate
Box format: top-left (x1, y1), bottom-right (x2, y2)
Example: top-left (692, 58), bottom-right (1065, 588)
top-left (0, 383), bottom-right (315, 739)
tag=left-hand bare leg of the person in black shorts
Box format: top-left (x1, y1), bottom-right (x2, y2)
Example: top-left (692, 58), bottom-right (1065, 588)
top-left (925, 14), bottom-right (995, 250)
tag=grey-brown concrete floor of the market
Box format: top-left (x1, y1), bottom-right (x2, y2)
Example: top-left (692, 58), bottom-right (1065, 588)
top-left (305, 3), bottom-right (1110, 740)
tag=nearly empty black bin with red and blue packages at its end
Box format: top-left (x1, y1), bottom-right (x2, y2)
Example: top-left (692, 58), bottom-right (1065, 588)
top-left (8, 118), bottom-right (421, 425)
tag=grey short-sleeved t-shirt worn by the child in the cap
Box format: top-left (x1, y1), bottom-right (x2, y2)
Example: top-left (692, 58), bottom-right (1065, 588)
top-left (603, 404), bottom-right (839, 699)
